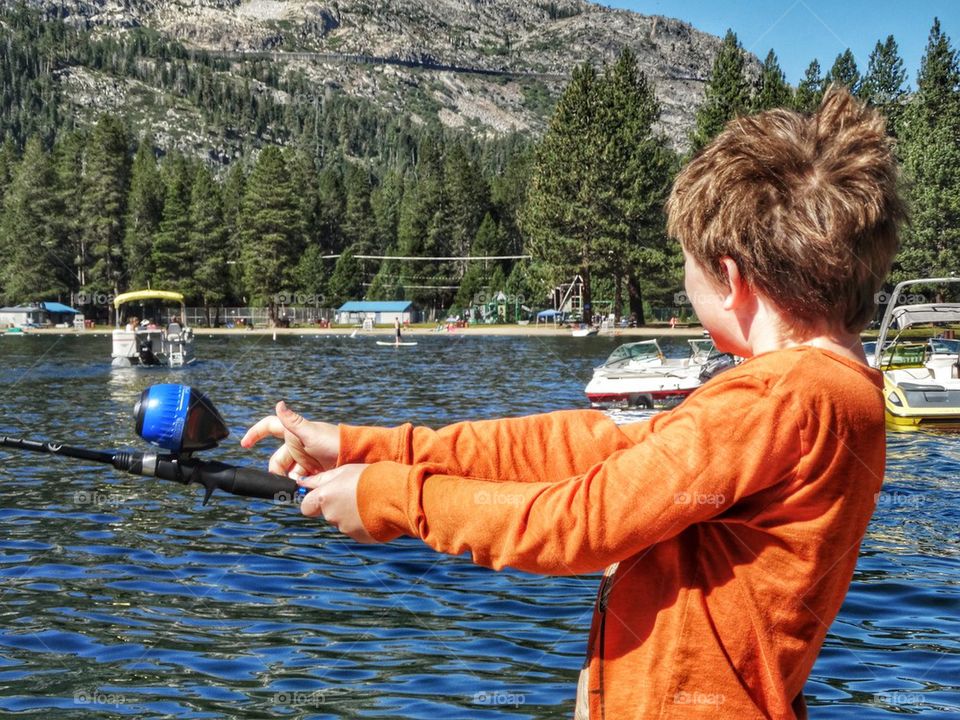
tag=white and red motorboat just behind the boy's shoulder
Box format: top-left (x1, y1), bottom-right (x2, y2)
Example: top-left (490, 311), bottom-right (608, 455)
top-left (585, 338), bottom-right (735, 408)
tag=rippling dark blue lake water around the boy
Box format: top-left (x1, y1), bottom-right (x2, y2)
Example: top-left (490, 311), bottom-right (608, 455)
top-left (0, 335), bottom-right (960, 720)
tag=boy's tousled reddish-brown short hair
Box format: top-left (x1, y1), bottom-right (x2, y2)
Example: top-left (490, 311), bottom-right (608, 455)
top-left (667, 87), bottom-right (906, 332)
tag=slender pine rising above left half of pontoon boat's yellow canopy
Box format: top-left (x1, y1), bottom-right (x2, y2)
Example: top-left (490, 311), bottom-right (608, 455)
top-left (123, 137), bottom-right (164, 289)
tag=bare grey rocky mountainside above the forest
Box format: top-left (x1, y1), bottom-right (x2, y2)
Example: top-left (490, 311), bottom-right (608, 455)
top-left (3, 0), bottom-right (756, 157)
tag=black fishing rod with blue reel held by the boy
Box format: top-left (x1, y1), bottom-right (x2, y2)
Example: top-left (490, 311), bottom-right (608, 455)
top-left (0, 384), bottom-right (306, 505)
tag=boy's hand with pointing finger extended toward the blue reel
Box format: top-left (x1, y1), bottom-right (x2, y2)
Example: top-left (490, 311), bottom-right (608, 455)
top-left (240, 400), bottom-right (340, 478)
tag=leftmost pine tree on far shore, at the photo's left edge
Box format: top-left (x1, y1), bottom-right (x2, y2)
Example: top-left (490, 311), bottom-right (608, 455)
top-left (0, 137), bottom-right (72, 303)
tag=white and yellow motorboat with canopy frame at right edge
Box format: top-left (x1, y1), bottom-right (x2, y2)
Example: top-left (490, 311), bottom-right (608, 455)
top-left (864, 277), bottom-right (960, 431)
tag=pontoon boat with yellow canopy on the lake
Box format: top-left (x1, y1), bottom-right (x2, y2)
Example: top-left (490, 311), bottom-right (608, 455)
top-left (111, 290), bottom-right (195, 367)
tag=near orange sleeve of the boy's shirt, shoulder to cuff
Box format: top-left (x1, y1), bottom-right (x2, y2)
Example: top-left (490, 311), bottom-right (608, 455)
top-left (358, 376), bottom-right (801, 575)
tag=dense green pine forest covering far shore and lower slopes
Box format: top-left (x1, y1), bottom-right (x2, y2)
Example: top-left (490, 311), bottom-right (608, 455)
top-left (0, 7), bottom-right (960, 322)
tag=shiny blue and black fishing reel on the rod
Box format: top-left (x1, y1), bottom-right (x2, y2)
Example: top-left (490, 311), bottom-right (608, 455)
top-left (133, 384), bottom-right (230, 455)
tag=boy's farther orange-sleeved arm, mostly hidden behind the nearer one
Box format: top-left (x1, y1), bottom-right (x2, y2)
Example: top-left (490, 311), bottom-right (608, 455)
top-left (337, 410), bottom-right (646, 482)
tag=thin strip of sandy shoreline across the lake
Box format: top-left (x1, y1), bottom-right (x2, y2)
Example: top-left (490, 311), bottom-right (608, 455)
top-left (13, 325), bottom-right (703, 340)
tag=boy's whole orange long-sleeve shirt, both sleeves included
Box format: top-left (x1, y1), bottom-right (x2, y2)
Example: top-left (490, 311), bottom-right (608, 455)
top-left (339, 347), bottom-right (885, 720)
